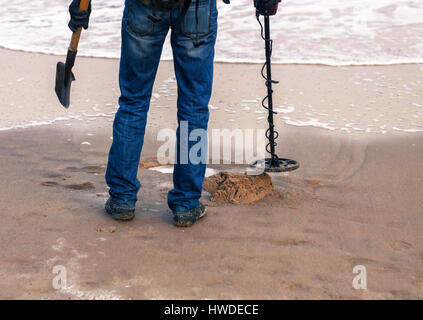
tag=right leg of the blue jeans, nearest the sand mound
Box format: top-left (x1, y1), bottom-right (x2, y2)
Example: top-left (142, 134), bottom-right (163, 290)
top-left (168, 0), bottom-right (218, 212)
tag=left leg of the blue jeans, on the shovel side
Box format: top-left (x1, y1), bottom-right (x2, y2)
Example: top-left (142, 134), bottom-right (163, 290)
top-left (106, 0), bottom-right (169, 207)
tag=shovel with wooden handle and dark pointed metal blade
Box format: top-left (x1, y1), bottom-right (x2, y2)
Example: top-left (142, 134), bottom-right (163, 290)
top-left (55, 0), bottom-right (90, 108)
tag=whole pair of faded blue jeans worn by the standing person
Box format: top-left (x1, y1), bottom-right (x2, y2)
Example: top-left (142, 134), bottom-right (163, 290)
top-left (106, 0), bottom-right (218, 212)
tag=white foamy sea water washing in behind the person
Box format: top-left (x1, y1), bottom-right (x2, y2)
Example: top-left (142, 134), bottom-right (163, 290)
top-left (0, 0), bottom-right (423, 65)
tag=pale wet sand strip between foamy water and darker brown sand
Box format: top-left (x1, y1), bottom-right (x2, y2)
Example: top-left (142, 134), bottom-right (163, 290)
top-left (0, 49), bottom-right (423, 135)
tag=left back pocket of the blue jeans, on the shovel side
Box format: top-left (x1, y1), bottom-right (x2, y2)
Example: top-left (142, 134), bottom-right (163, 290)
top-left (127, 0), bottom-right (154, 36)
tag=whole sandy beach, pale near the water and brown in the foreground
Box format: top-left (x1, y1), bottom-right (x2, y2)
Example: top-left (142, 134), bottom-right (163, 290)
top-left (0, 49), bottom-right (423, 299)
